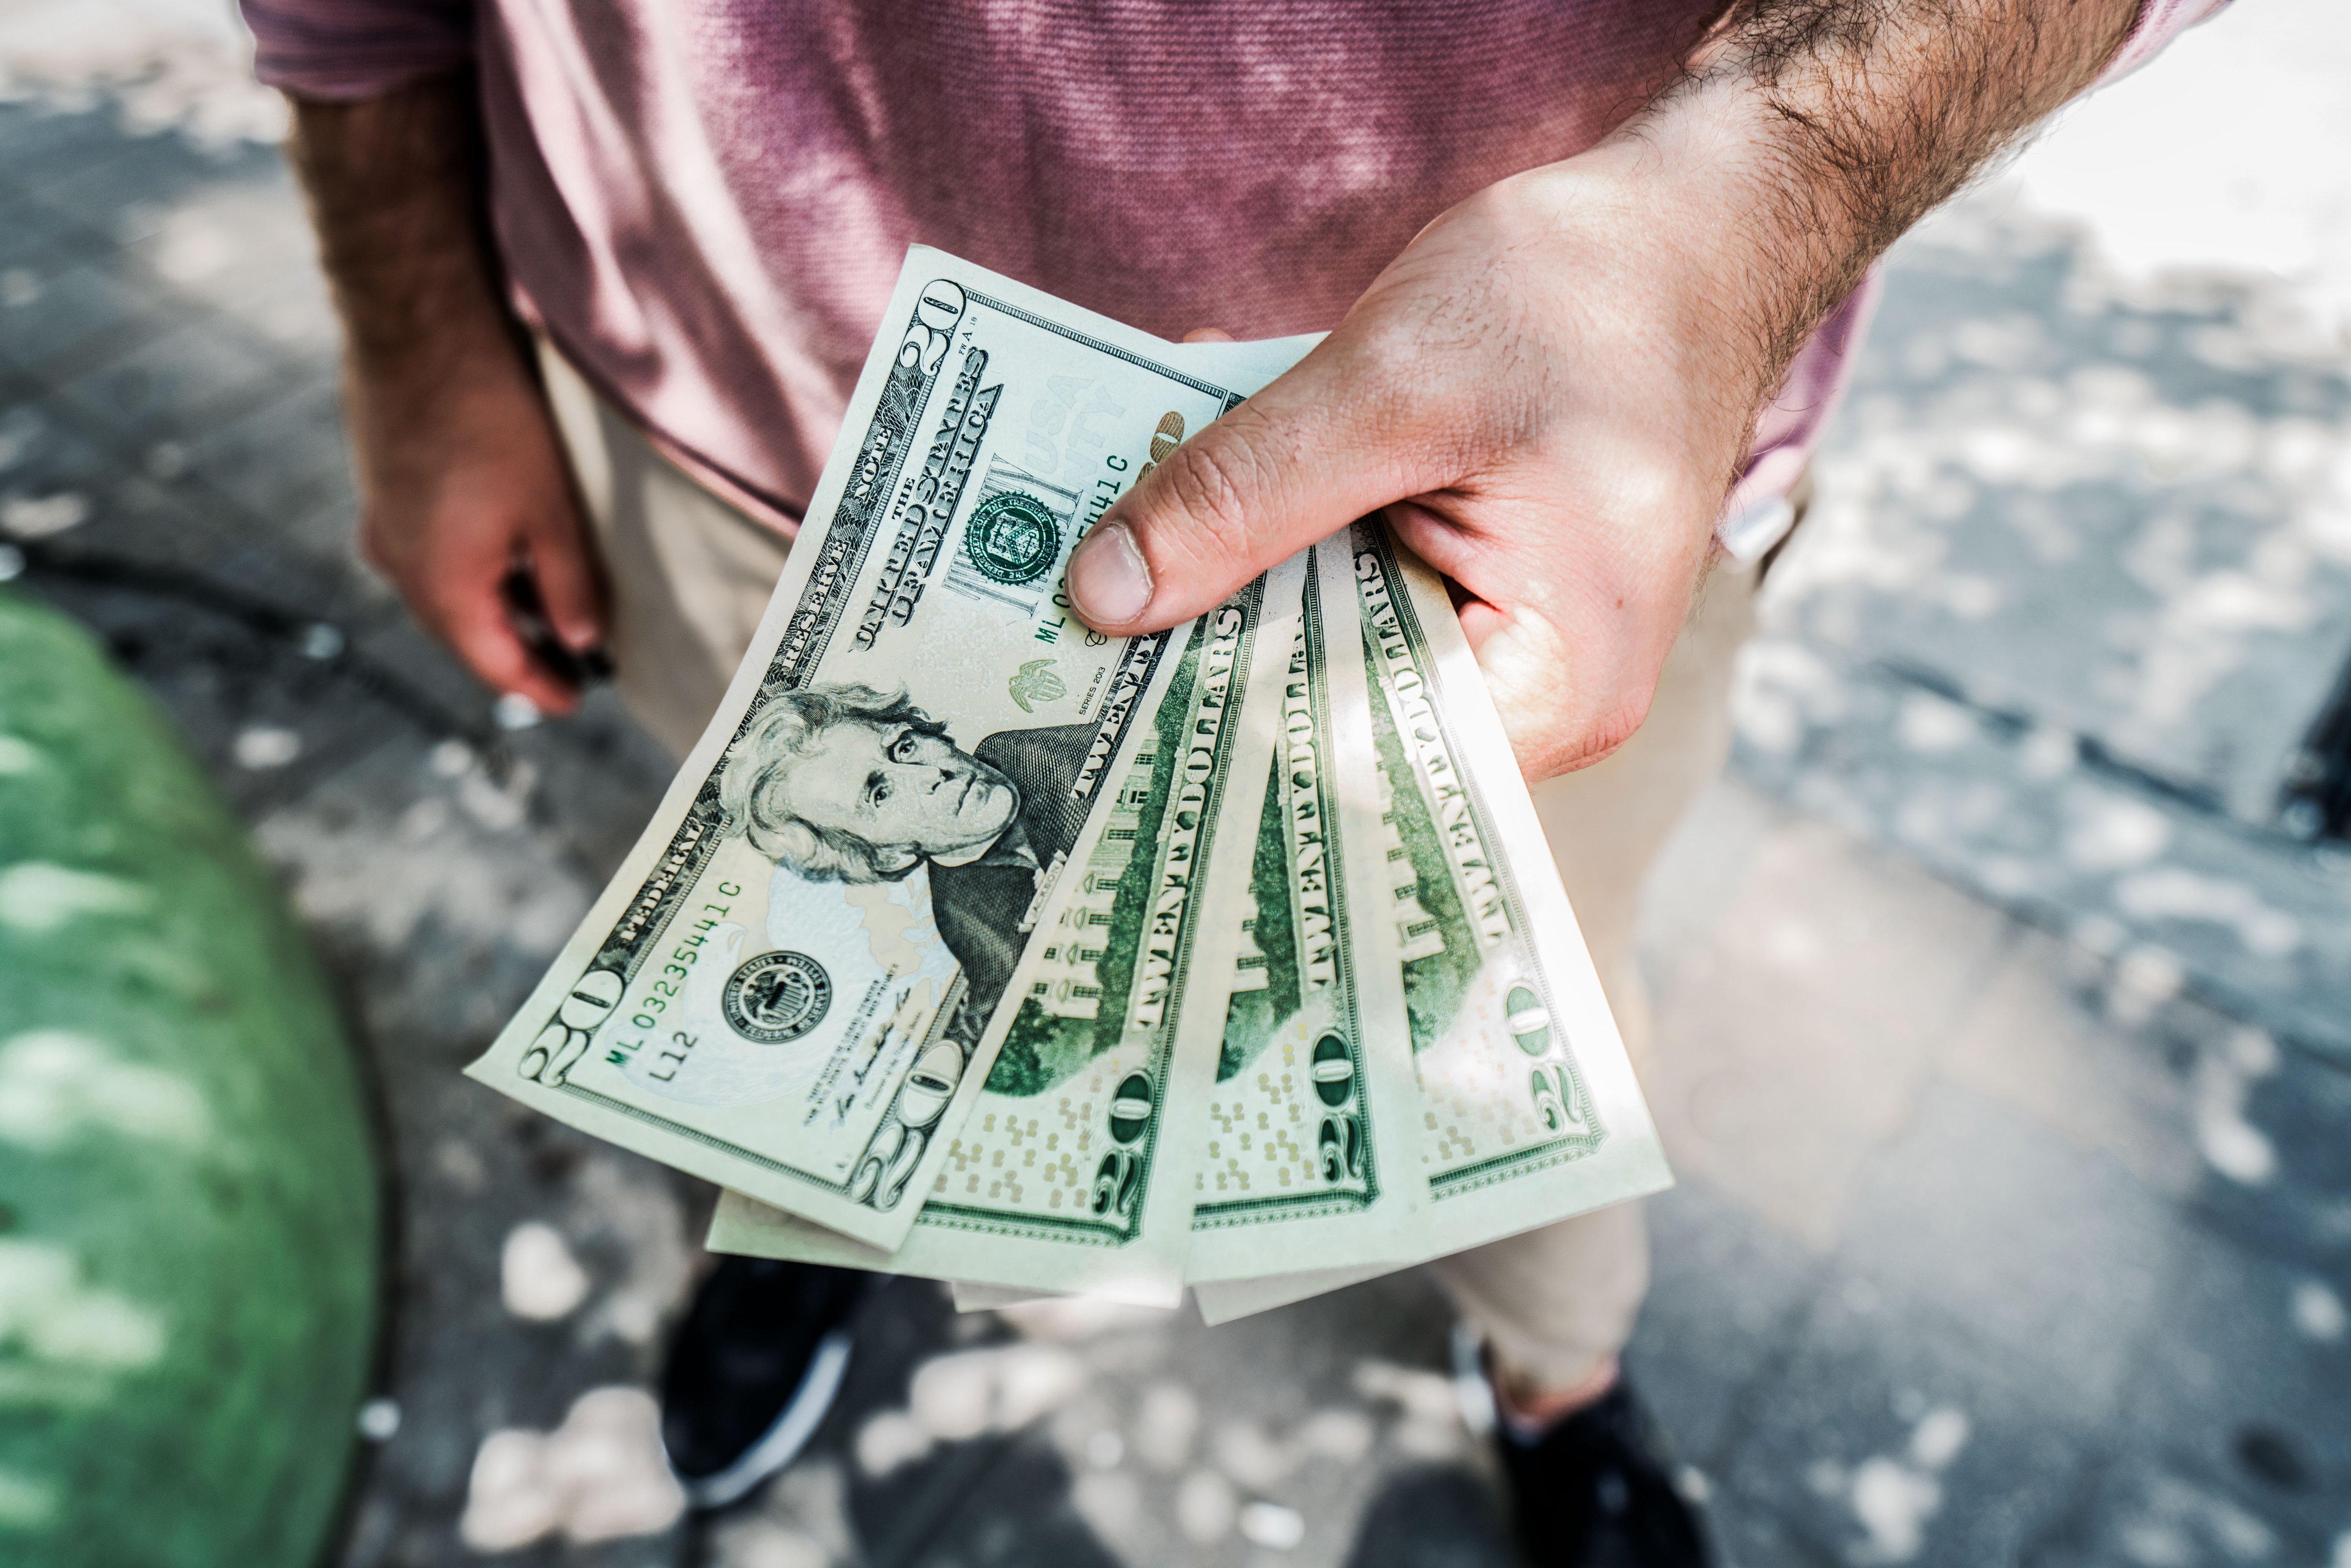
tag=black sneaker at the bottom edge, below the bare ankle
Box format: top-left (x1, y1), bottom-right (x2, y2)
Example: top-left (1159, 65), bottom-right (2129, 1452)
top-left (1495, 1373), bottom-right (1714, 1568)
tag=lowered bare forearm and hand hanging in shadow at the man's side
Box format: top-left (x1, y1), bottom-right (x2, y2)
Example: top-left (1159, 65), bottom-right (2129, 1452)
top-left (292, 77), bottom-right (604, 712)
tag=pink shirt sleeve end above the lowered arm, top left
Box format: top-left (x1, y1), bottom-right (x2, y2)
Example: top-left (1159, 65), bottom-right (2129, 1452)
top-left (240, 0), bottom-right (475, 101)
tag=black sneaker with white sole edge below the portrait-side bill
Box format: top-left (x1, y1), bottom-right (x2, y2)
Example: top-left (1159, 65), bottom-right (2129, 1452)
top-left (660, 1258), bottom-right (875, 1509)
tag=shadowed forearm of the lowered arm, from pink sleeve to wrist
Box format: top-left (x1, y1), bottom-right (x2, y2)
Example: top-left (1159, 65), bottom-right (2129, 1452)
top-left (287, 73), bottom-right (515, 397)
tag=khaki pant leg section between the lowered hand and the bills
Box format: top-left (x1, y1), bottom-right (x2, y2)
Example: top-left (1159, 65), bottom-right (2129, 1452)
top-left (538, 341), bottom-right (792, 757)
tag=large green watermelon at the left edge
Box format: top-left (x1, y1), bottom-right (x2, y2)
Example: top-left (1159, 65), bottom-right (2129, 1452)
top-left (0, 590), bottom-right (381, 1568)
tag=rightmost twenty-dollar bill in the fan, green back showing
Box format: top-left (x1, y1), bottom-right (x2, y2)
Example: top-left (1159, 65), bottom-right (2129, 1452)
top-left (1317, 520), bottom-right (1672, 1258)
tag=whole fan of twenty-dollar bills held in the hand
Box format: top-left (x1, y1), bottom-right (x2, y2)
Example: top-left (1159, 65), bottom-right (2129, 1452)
top-left (468, 249), bottom-right (1667, 1314)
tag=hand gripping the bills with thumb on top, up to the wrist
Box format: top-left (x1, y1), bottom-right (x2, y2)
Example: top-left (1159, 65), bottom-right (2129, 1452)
top-left (1070, 148), bottom-right (1775, 781)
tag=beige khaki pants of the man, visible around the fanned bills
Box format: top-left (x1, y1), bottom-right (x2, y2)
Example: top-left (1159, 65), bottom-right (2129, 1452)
top-left (541, 353), bottom-right (1756, 1389)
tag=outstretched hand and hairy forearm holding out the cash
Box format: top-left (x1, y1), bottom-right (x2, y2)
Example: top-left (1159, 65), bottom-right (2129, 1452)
top-left (1070, 0), bottom-right (2137, 778)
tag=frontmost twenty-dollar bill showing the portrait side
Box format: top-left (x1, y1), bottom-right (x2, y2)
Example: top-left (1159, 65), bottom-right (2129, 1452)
top-left (468, 249), bottom-right (1303, 1248)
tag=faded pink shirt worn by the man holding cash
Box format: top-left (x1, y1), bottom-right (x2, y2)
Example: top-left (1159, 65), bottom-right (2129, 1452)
top-left (245, 0), bottom-right (2224, 540)
